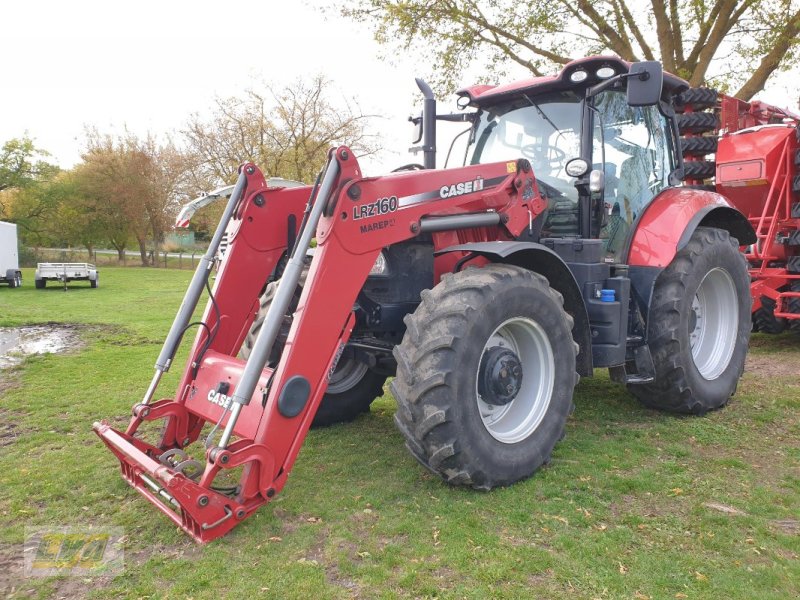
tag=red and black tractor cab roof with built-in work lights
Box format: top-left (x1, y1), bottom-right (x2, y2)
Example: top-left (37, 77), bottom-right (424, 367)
top-left (456, 56), bottom-right (689, 107)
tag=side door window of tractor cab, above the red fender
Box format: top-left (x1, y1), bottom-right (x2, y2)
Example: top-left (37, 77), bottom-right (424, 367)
top-left (592, 91), bottom-right (673, 260)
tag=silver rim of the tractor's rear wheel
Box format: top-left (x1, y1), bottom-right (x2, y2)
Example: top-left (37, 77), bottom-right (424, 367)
top-left (689, 268), bottom-right (739, 381)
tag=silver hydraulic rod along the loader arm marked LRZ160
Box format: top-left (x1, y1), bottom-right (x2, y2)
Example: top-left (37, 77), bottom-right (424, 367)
top-left (218, 153), bottom-right (344, 448)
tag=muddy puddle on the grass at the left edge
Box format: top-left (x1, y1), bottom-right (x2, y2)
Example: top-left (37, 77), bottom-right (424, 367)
top-left (0, 323), bottom-right (81, 369)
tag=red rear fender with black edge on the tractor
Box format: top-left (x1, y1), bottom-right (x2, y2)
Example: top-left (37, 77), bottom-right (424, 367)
top-left (626, 187), bottom-right (756, 268)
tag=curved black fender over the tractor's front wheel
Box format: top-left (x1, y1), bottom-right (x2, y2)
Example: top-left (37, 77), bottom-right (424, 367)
top-left (436, 242), bottom-right (593, 377)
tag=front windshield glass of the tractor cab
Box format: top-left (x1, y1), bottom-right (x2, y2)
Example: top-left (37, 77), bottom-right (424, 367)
top-left (470, 91), bottom-right (582, 203)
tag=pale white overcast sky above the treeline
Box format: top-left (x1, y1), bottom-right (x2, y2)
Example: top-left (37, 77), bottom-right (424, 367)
top-left (0, 0), bottom-right (798, 182)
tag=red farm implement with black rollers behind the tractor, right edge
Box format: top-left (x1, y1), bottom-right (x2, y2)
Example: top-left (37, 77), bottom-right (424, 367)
top-left (677, 88), bottom-right (800, 333)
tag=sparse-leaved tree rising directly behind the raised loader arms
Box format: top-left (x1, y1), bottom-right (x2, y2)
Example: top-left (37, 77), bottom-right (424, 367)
top-left (182, 76), bottom-right (377, 191)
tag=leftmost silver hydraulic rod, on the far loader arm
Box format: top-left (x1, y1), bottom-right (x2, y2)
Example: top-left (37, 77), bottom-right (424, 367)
top-left (142, 169), bottom-right (247, 404)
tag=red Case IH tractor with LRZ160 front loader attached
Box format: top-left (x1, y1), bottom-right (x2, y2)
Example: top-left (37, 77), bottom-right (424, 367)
top-left (94, 57), bottom-right (756, 542)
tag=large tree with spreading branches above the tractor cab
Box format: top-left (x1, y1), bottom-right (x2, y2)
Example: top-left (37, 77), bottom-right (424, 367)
top-left (343, 0), bottom-right (800, 100)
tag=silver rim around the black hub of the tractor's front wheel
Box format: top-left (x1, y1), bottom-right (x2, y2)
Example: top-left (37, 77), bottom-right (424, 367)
top-left (475, 317), bottom-right (555, 444)
